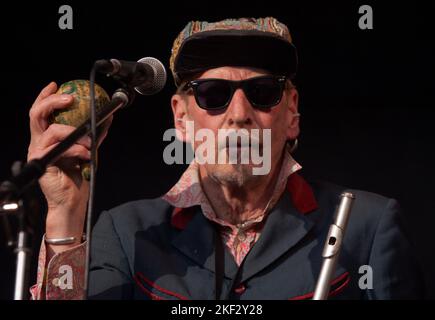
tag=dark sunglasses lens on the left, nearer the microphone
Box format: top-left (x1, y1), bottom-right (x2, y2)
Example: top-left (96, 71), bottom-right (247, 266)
top-left (195, 80), bottom-right (231, 110)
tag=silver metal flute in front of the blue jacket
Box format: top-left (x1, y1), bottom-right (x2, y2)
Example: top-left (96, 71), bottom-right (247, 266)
top-left (313, 192), bottom-right (355, 300)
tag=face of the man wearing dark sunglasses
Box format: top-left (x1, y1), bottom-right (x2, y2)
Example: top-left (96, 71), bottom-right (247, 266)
top-left (172, 67), bottom-right (299, 186)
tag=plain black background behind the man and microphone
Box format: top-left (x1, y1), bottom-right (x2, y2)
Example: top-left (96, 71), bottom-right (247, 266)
top-left (0, 0), bottom-right (435, 299)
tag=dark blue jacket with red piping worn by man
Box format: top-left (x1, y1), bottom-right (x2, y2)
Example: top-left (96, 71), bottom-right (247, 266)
top-left (89, 182), bottom-right (423, 300)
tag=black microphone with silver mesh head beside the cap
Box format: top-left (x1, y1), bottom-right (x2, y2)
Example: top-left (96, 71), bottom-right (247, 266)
top-left (95, 57), bottom-right (166, 95)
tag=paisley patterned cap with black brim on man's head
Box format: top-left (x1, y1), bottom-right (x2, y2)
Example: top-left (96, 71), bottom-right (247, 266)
top-left (170, 17), bottom-right (298, 86)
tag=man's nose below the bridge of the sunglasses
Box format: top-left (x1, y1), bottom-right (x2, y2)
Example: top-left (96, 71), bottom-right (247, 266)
top-left (226, 88), bottom-right (253, 127)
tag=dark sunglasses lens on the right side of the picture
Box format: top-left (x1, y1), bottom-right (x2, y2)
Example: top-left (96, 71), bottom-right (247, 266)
top-left (245, 77), bottom-right (282, 108)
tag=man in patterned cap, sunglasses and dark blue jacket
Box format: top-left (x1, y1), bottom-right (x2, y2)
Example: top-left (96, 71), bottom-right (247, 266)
top-left (28, 18), bottom-right (421, 299)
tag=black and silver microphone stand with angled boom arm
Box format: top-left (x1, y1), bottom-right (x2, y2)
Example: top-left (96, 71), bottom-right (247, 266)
top-left (0, 88), bottom-right (134, 300)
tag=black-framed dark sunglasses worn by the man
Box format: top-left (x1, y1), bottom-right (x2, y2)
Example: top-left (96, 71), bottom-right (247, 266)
top-left (182, 76), bottom-right (286, 110)
